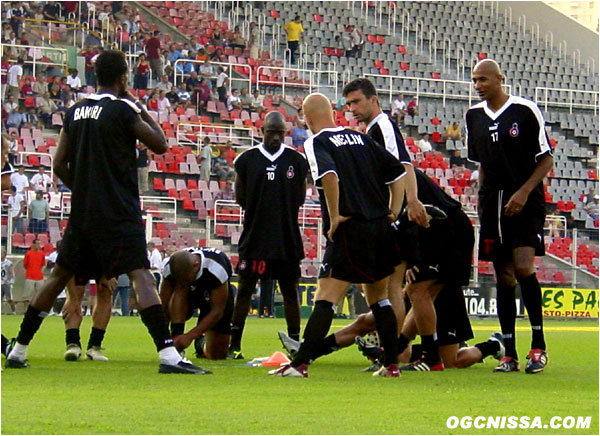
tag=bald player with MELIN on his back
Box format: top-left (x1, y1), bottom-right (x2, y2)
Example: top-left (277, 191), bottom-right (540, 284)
top-left (270, 93), bottom-right (405, 377)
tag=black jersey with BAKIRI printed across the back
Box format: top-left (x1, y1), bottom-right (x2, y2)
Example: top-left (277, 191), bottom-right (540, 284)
top-left (63, 94), bottom-right (144, 237)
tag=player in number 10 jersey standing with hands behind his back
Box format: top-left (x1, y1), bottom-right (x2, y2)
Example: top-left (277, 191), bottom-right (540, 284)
top-left (230, 112), bottom-right (308, 359)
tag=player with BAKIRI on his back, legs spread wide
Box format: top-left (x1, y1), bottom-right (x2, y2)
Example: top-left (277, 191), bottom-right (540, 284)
top-left (6, 50), bottom-right (204, 374)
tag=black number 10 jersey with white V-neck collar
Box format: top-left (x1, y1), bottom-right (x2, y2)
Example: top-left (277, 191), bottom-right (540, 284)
top-left (234, 144), bottom-right (308, 260)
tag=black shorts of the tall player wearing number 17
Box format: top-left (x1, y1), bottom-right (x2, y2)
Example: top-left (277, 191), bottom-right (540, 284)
top-left (478, 191), bottom-right (546, 261)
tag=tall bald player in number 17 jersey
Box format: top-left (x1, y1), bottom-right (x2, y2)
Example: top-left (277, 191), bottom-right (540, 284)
top-left (465, 59), bottom-right (553, 373)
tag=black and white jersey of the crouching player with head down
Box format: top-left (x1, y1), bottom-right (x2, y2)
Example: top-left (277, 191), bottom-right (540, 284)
top-left (163, 248), bottom-right (233, 300)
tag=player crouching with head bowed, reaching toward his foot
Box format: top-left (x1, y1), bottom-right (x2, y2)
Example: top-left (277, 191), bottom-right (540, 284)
top-left (160, 248), bottom-right (235, 360)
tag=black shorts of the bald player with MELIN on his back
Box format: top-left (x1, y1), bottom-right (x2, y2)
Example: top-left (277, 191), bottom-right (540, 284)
top-left (319, 217), bottom-right (399, 283)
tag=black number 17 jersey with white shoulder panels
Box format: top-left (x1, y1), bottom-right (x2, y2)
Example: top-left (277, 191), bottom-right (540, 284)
top-left (465, 96), bottom-right (550, 198)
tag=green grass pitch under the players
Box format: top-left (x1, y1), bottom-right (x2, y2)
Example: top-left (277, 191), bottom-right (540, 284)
top-left (1, 316), bottom-right (598, 434)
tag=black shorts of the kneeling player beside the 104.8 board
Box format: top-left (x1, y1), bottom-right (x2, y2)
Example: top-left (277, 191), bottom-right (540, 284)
top-left (434, 285), bottom-right (474, 345)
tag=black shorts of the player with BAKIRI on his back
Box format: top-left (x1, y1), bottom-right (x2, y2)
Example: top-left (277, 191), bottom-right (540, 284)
top-left (56, 225), bottom-right (150, 283)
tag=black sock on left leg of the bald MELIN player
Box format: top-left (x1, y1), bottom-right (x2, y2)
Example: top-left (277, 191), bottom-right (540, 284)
top-left (292, 300), bottom-right (333, 366)
